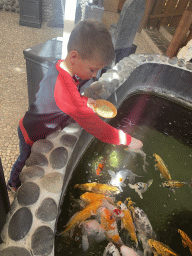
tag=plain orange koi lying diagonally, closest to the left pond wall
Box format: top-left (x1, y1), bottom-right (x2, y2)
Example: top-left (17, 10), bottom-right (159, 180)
top-left (62, 200), bottom-right (103, 236)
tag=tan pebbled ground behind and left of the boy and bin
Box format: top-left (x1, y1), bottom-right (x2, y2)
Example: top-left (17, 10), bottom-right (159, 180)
top-left (0, 10), bottom-right (154, 200)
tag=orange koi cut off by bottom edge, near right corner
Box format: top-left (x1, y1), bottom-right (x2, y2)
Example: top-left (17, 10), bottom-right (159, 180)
top-left (148, 239), bottom-right (179, 256)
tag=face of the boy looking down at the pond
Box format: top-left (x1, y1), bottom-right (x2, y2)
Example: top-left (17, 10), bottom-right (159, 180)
top-left (73, 51), bottom-right (105, 80)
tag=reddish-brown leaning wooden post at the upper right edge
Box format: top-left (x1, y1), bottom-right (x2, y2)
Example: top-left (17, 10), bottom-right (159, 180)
top-left (166, 10), bottom-right (192, 58)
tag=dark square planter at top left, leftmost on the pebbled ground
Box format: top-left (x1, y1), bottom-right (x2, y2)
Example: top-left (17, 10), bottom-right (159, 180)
top-left (19, 0), bottom-right (42, 28)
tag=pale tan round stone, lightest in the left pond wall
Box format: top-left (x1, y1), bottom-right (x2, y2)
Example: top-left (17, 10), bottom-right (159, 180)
top-left (41, 172), bottom-right (63, 193)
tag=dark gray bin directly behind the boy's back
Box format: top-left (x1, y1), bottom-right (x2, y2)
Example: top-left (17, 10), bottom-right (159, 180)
top-left (23, 37), bottom-right (63, 105)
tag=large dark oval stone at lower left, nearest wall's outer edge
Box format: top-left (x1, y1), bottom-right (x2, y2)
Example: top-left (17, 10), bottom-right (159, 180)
top-left (8, 207), bottom-right (33, 241)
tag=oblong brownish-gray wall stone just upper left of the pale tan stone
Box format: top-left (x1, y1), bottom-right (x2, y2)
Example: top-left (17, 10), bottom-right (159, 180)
top-left (19, 165), bottom-right (45, 183)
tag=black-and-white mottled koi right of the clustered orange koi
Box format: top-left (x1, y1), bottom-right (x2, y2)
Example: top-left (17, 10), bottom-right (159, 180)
top-left (133, 207), bottom-right (156, 255)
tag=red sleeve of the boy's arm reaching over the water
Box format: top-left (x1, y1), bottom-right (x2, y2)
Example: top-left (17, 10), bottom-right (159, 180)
top-left (54, 61), bottom-right (131, 145)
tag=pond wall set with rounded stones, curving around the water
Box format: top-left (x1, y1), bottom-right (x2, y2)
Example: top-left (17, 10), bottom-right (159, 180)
top-left (0, 54), bottom-right (192, 256)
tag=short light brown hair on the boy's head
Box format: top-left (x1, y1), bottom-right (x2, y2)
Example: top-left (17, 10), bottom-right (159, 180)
top-left (67, 20), bottom-right (115, 65)
